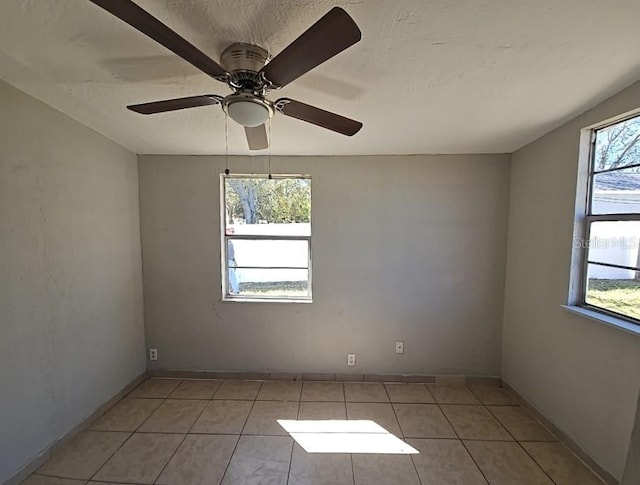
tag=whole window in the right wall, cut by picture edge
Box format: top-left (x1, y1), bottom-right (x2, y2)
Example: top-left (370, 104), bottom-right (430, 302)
top-left (581, 116), bottom-right (640, 323)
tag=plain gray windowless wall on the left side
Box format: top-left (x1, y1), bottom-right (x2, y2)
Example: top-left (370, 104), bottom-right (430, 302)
top-left (0, 82), bottom-right (145, 482)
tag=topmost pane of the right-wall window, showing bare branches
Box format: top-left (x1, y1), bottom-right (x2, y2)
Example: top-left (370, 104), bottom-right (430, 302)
top-left (593, 117), bottom-right (640, 172)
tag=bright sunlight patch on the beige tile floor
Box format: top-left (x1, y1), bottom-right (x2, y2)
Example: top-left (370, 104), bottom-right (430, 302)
top-left (278, 419), bottom-right (419, 455)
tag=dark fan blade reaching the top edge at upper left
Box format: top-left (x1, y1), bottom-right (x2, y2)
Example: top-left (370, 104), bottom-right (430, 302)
top-left (89, 0), bottom-right (227, 78)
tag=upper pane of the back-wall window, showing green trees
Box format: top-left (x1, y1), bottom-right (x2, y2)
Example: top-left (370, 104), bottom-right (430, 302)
top-left (224, 177), bottom-right (311, 236)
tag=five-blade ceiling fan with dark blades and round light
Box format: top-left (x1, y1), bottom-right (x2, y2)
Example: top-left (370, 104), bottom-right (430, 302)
top-left (89, 0), bottom-right (362, 150)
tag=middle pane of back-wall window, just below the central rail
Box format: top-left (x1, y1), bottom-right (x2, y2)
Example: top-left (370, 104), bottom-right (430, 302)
top-left (227, 238), bottom-right (309, 269)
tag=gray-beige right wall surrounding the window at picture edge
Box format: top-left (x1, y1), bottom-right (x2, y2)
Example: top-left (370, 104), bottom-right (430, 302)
top-left (502, 79), bottom-right (640, 478)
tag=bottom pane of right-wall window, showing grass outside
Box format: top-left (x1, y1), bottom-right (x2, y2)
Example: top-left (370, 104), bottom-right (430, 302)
top-left (586, 264), bottom-right (640, 318)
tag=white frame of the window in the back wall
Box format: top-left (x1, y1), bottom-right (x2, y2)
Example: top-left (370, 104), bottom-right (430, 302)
top-left (220, 173), bottom-right (313, 303)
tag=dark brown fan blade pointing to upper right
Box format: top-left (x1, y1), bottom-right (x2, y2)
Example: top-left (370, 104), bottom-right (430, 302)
top-left (261, 7), bottom-right (362, 87)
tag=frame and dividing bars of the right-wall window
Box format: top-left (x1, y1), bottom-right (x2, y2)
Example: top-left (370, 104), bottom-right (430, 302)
top-left (578, 111), bottom-right (640, 330)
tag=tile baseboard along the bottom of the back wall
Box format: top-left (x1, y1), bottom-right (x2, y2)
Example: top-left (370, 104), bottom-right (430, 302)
top-left (148, 369), bottom-right (501, 386)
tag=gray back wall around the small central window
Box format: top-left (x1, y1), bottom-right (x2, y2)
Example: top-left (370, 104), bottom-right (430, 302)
top-left (139, 155), bottom-right (509, 376)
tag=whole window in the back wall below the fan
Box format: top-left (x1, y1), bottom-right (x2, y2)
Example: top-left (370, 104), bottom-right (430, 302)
top-left (221, 175), bottom-right (311, 301)
